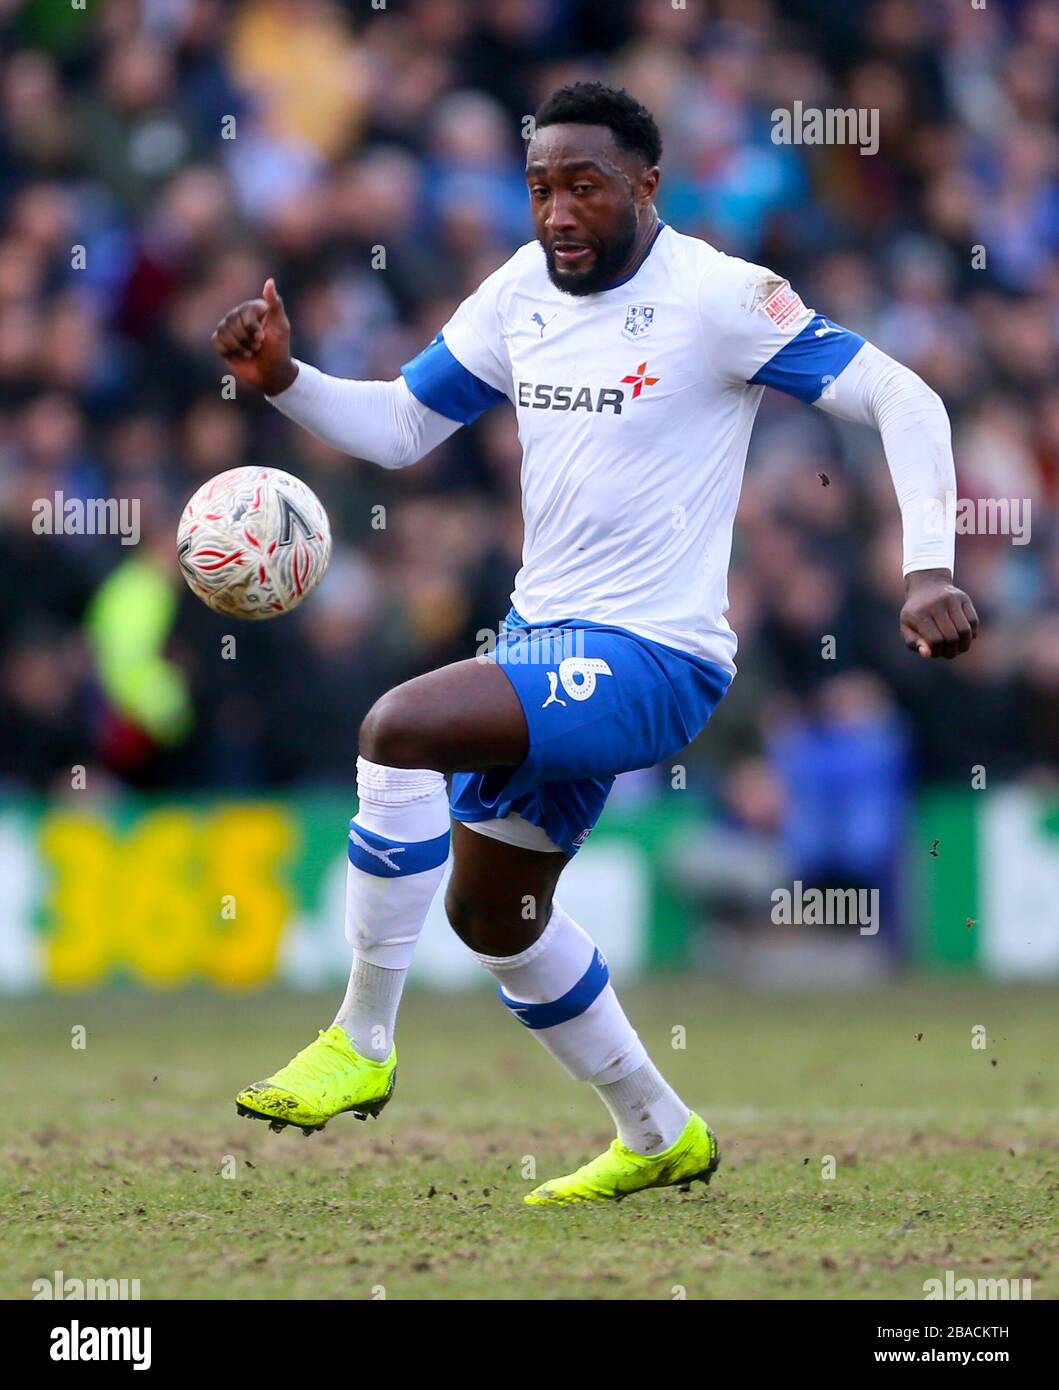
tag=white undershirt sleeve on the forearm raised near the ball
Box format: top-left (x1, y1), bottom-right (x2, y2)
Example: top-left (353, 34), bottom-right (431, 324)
top-left (265, 361), bottom-right (460, 468)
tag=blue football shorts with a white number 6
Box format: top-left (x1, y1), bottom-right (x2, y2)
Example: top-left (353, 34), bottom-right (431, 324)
top-left (450, 609), bottom-right (732, 855)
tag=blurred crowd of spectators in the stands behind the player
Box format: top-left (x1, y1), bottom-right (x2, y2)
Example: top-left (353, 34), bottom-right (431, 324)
top-left (0, 0), bottom-right (1059, 917)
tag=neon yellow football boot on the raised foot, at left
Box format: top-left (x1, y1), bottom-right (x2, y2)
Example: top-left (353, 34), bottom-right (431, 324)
top-left (235, 1023), bottom-right (397, 1134)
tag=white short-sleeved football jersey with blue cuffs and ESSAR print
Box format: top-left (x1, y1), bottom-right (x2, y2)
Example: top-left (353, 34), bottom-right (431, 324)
top-left (402, 224), bottom-right (863, 671)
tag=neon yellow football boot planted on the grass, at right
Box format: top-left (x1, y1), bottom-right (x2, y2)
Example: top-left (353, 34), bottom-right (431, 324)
top-left (523, 1111), bottom-right (721, 1207)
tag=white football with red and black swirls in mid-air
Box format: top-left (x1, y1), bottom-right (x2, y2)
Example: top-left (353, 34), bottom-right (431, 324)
top-left (177, 466), bottom-right (331, 619)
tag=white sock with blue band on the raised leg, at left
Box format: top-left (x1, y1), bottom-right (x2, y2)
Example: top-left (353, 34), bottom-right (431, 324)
top-left (335, 758), bottom-right (450, 1062)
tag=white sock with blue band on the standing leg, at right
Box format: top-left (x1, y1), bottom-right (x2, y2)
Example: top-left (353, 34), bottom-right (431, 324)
top-left (475, 902), bottom-right (691, 1154)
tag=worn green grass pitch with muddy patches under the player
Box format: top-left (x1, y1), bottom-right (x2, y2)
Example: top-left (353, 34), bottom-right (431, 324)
top-left (0, 980), bottom-right (1059, 1300)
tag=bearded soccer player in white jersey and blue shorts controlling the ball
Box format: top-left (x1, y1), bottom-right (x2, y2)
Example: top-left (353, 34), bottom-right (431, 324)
top-left (213, 82), bottom-right (978, 1205)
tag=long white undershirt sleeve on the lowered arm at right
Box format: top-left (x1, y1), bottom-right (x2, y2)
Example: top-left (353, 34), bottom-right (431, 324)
top-left (813, 343), bottom-right (956, 574)
